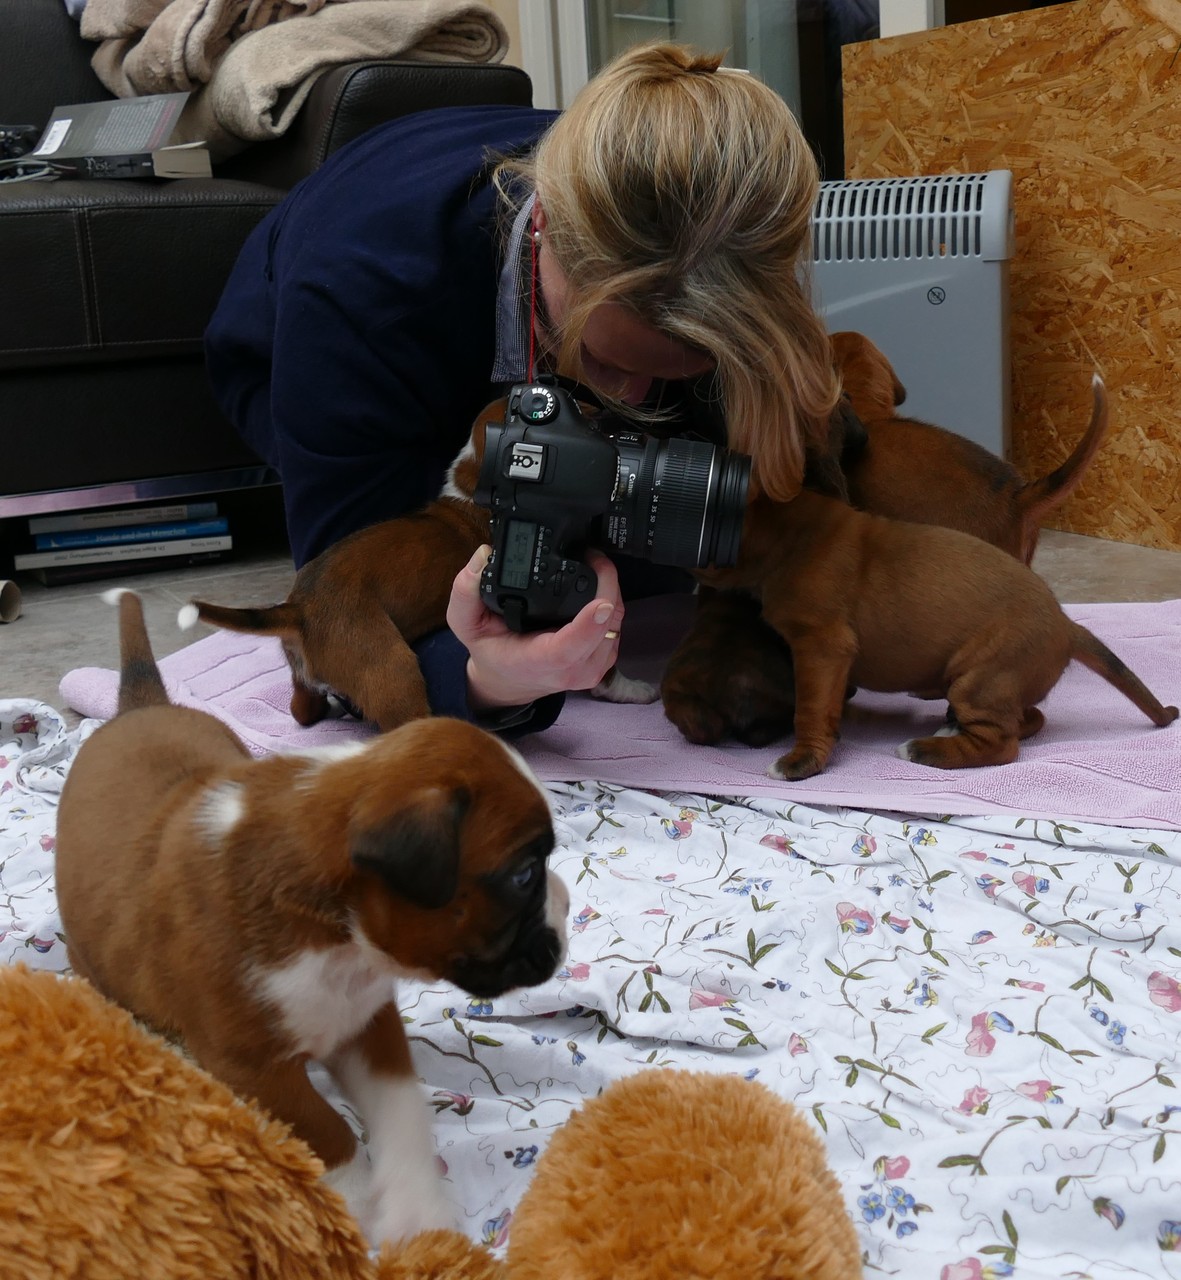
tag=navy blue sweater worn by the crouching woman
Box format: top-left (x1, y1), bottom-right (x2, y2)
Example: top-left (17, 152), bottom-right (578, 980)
top-left (206, 106), bottom-right (560, 730)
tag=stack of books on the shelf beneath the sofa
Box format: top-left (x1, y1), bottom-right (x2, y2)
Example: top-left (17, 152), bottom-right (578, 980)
top-left (13, 502), bottom-right (233, 586)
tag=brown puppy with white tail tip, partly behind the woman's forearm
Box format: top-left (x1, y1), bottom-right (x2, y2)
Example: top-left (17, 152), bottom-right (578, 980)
top-left (189, 399), bottom-right (656, 730)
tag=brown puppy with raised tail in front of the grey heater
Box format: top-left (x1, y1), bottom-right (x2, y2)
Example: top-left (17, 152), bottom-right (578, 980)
top-left (832, 333), bottom-right (1108, 564)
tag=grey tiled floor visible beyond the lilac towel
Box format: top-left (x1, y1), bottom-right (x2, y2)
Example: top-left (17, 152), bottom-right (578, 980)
top-left (0, 530), bottom-right (1181, 709)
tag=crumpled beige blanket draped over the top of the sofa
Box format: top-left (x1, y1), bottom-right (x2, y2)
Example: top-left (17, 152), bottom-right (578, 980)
top-left (82, 0), bottom-right (508, 159)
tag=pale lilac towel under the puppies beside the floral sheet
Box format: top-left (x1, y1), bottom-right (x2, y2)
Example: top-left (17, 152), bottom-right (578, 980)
top-left (61, 596), bottom-right (1181, 829)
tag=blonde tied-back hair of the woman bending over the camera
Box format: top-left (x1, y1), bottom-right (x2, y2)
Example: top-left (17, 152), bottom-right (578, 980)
top-left (500, 44), bottom-right (838, 500)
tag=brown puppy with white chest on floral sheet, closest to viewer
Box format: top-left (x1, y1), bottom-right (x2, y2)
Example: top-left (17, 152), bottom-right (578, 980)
top-left (56, 591), bottom-right (569, 1243)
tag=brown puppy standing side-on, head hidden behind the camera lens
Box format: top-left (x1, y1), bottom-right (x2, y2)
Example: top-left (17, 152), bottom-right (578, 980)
top-left (696, 379), bottom-right (1177, 780)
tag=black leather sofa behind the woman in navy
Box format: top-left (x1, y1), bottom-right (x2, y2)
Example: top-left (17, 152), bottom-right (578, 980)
top-left (0, 0), bottom-right (532, 520)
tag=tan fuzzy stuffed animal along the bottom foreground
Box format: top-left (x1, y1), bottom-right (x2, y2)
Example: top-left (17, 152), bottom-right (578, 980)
top-left (0, 966), bottom-right (861, 1280)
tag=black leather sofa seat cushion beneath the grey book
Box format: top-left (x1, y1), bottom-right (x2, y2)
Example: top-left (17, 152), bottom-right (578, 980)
top-left (0, 178), bottom-right (284, 369)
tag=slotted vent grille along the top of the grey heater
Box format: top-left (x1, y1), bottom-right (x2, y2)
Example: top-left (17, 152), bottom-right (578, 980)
top-left (812, 170), bottom-right (1012, 262)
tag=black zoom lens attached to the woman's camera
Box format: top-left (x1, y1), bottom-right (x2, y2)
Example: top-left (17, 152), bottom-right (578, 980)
top-left (604, 434), bottom-right (751, 568)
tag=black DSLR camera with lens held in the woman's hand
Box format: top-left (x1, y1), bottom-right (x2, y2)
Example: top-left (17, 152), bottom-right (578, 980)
top-left (475, 378), bottom-right (751, 631)
